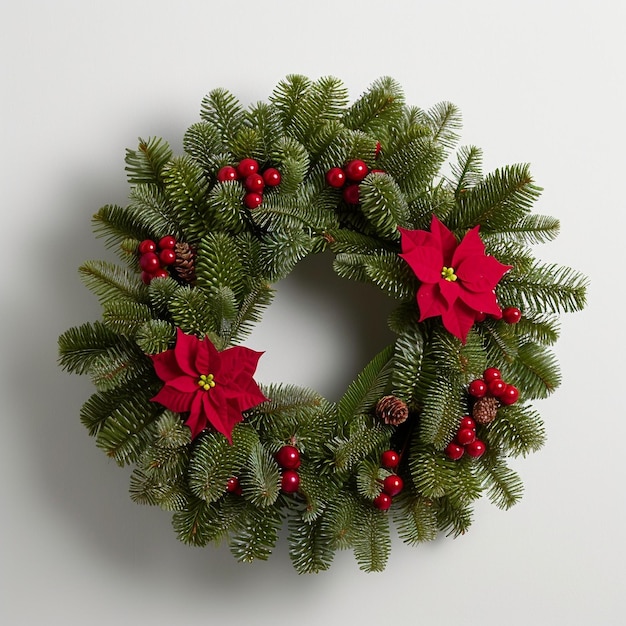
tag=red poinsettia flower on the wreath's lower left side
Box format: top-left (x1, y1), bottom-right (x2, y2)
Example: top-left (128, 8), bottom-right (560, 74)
top-left (150, 328), bottom-right (267, 443)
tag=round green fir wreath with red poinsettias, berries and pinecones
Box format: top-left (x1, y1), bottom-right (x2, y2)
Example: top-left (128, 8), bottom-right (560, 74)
top-left (59, 75), bottom-right (587, 573)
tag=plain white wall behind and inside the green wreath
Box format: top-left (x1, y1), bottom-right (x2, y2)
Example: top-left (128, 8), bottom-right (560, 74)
top-left (0, 0), bottom-right (626, 626)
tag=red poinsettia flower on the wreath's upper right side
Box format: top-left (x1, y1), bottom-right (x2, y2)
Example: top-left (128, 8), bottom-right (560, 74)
top-left (399, 215), bottom-right (511, 343)
